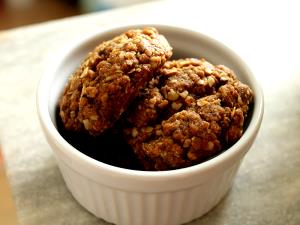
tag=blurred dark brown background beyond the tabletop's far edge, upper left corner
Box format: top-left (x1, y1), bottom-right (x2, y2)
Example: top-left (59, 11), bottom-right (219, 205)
top-left (0, 0), bottom-right (158, 30)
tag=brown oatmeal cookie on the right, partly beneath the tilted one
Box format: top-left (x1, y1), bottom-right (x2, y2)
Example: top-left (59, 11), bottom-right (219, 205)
top-left (124, 58), bottom-right (253, 170)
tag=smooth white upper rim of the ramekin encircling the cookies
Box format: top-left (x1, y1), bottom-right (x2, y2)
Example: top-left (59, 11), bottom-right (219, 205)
top-left (36, 24), bottom-right (264, 190)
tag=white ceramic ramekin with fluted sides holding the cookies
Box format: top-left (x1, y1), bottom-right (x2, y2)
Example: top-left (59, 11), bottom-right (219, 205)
top-left (37, 25), bottom-right (263, 225)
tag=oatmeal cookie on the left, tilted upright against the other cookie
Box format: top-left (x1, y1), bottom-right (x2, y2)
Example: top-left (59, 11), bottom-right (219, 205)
top-left (60, 27), bottom-right (172, 135)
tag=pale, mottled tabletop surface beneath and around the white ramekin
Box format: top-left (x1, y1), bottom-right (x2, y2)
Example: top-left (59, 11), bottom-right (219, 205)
top-left (0, 0), bottom-right (300, 225)
